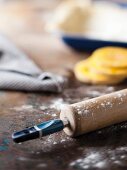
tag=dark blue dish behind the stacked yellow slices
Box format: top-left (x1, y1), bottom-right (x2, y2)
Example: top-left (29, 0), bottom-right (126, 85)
top-left (61, 3), bottom-right (127, 52)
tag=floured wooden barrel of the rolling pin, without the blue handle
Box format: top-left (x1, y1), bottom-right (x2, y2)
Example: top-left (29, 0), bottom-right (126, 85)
top-left (60, 89), bottom-right (127, 136)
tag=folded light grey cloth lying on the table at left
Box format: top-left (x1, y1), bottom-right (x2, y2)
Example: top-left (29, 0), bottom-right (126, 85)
top-left (0, 35), bottom-right (67, 92)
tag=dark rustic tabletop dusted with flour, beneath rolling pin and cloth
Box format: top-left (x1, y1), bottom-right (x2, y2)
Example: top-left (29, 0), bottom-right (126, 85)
top-left (0, 1), bottom-right (127, 170)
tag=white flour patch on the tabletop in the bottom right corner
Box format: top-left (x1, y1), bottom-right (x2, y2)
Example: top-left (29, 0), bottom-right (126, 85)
top-left (69, 146), bottom-right (127, 170)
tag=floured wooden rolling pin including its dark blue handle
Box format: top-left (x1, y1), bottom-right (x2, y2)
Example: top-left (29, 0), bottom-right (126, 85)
top-left (12, 89), bottom-right (127, 143)
